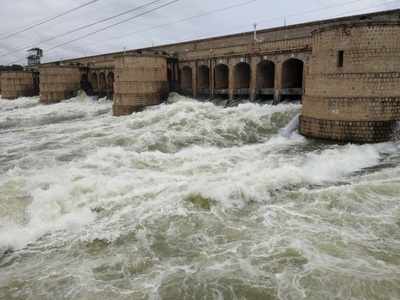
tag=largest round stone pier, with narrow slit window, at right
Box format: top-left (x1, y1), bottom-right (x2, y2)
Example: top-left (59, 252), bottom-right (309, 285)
top-left (300, 22), bottom-right (400, 142)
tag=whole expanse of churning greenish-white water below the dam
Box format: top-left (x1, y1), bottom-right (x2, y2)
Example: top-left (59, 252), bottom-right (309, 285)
top-left (0, 95), bottom-right (400, 300)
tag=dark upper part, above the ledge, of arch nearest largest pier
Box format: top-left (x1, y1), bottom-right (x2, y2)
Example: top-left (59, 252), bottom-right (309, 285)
top-left (282, 58), bottom-right (304, 89)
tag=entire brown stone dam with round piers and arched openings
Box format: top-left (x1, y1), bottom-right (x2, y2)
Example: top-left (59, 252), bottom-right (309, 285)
top-left (0, 10), bottom-right (400, 143)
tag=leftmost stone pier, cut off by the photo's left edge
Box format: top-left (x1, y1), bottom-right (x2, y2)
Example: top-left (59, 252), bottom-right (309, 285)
top-left (1, 71), bottom-right (37, 100)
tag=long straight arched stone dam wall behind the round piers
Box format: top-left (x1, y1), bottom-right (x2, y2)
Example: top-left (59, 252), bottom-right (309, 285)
top-left (48, 10), bottom-right (400, 102)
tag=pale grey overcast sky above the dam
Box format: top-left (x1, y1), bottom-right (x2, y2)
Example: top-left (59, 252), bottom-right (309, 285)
top-left (0, 0), bottom-right (400, 64)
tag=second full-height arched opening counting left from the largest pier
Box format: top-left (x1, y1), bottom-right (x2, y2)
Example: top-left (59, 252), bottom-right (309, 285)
top-left (257, 60), bottom-right (275, 100)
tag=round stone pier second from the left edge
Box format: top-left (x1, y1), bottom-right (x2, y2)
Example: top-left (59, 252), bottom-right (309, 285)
top-left (40, 65), bottom-right (81, 104)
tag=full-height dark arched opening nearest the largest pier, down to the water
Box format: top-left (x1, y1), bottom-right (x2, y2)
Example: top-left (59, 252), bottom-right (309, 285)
top-left (282, 58), bottom-right (304, 99)
